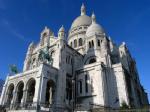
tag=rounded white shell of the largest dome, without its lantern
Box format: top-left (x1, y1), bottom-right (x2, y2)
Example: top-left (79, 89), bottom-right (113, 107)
top-left (71, 15), bottom-right (92, 29)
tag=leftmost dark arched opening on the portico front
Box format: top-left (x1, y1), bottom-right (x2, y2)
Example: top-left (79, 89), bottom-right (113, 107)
top-left (6, 83), bottom-right (14, 104)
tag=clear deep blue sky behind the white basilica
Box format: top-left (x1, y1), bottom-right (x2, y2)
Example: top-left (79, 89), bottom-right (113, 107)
top-left (0, 0), bottom-right (150, 99)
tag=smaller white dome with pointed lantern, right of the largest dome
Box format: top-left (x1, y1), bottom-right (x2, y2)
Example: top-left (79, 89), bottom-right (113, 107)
top-left (86, 14), bottom-right (104, 37)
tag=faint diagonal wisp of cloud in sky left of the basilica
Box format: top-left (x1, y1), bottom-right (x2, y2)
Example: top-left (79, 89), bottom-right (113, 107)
top-left (1, 19), bottom-right (28, 41)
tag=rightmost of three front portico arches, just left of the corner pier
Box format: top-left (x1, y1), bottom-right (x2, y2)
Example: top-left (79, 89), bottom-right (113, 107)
top-left (26, 78), bottom-right (36, 103)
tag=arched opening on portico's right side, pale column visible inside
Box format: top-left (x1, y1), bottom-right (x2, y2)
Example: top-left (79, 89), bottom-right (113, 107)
top-left (45, 79), bottom-right (56, 104)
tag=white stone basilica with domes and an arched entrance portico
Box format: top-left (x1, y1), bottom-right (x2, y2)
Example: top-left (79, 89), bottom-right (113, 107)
top-left (0, 4), bottom-right (148, 112)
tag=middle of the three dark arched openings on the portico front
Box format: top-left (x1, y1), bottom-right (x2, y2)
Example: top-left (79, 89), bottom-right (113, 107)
top-left (15, 81), bottom-right (24, 104)
